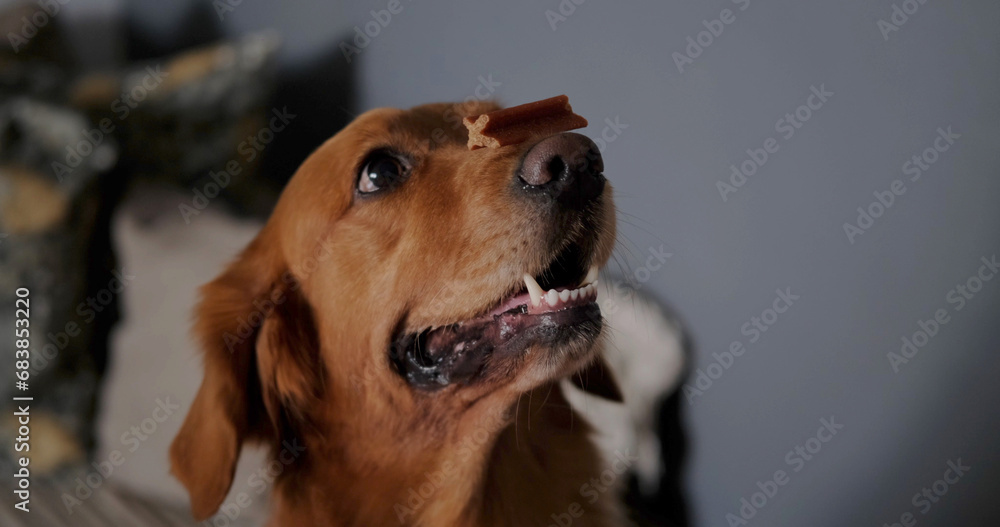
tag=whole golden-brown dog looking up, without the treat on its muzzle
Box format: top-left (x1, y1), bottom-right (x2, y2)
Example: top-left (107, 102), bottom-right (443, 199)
top-left (170, 102), bottom-right (623, 527)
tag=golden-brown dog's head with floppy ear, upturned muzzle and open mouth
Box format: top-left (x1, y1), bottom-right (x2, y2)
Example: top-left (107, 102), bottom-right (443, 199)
top-left (171, 103), bottom-right (617, 518)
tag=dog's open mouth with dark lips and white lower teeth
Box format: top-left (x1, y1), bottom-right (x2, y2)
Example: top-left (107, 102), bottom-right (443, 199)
top-left (389, 244), bottom-right (602, 388)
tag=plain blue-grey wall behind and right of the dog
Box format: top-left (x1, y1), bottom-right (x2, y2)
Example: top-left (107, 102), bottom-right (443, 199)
top-left (109, 0), bottom-right (1000, 527)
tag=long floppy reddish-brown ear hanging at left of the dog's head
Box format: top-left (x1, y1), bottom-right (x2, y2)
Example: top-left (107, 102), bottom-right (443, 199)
top-left (170, 237), bottom-right (320, 520)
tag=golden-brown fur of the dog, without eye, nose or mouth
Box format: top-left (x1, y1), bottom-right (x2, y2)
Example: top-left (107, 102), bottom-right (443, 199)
top-left (171, 104), bottom-right (617, 526)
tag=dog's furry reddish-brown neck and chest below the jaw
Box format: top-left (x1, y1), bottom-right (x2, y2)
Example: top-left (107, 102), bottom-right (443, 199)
top-left (275, 383), bottom-right (615, 527)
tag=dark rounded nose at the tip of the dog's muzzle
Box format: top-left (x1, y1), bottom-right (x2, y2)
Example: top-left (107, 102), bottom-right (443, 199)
top-left (518, 133), bottom-right (605, 207)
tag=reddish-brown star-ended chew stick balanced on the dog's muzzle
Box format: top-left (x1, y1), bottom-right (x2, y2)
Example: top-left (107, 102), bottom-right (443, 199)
top-left (462, 95), bottom-right (587, 150)
